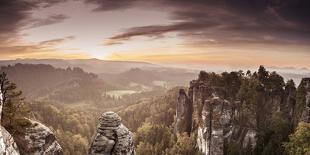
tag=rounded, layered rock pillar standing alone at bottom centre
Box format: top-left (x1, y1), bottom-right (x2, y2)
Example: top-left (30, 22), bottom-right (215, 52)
top-left (89, 112), bottom-right (135, 155)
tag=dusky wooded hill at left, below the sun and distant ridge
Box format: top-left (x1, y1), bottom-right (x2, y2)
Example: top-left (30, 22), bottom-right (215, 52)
top-left (0, 63), bottom-right (110, 101)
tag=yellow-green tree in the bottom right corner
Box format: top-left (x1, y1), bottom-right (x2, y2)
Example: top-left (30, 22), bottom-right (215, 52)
top-left (284, 122), bottom-right (310, 155)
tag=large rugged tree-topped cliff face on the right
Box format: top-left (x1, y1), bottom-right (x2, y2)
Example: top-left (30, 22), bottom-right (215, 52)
top-left (175, 73), bottom-right (310, 155)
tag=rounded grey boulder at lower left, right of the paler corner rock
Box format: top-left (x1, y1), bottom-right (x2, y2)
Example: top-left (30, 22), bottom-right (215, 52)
top-left (14, 120), bottom-right (63, 155)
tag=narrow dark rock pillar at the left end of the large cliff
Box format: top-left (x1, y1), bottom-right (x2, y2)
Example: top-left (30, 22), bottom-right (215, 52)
top-left (174, 89), bottom-right (193, 134)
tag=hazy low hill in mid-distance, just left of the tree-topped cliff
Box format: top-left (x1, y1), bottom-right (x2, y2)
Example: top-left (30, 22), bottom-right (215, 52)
top-left (99, 68), bottom-right (195, 89)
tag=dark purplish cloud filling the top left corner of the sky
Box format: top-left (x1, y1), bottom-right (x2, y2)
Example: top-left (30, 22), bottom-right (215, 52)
top-left (0, 0), bottom-right (65, 44)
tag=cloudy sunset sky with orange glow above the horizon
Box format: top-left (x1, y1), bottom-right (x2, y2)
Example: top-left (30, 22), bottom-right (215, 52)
top-left (0, 0), bottom-right (310, 69)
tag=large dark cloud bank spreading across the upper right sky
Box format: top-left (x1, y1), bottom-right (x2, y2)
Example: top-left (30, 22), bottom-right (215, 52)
top-left (94, 0), bottom-right (310, 45)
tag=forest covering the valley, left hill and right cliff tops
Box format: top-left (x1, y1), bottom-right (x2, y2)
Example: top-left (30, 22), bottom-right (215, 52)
top-left (0, 64), bottom-right (310, 155)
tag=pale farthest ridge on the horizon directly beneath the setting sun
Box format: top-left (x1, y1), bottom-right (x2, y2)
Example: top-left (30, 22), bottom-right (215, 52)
top-left (0, 59), bottom-right (160, 74)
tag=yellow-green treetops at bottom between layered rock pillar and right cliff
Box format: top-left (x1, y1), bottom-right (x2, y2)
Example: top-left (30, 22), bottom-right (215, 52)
top-left (135, 123), bottom-right (198, 155)
